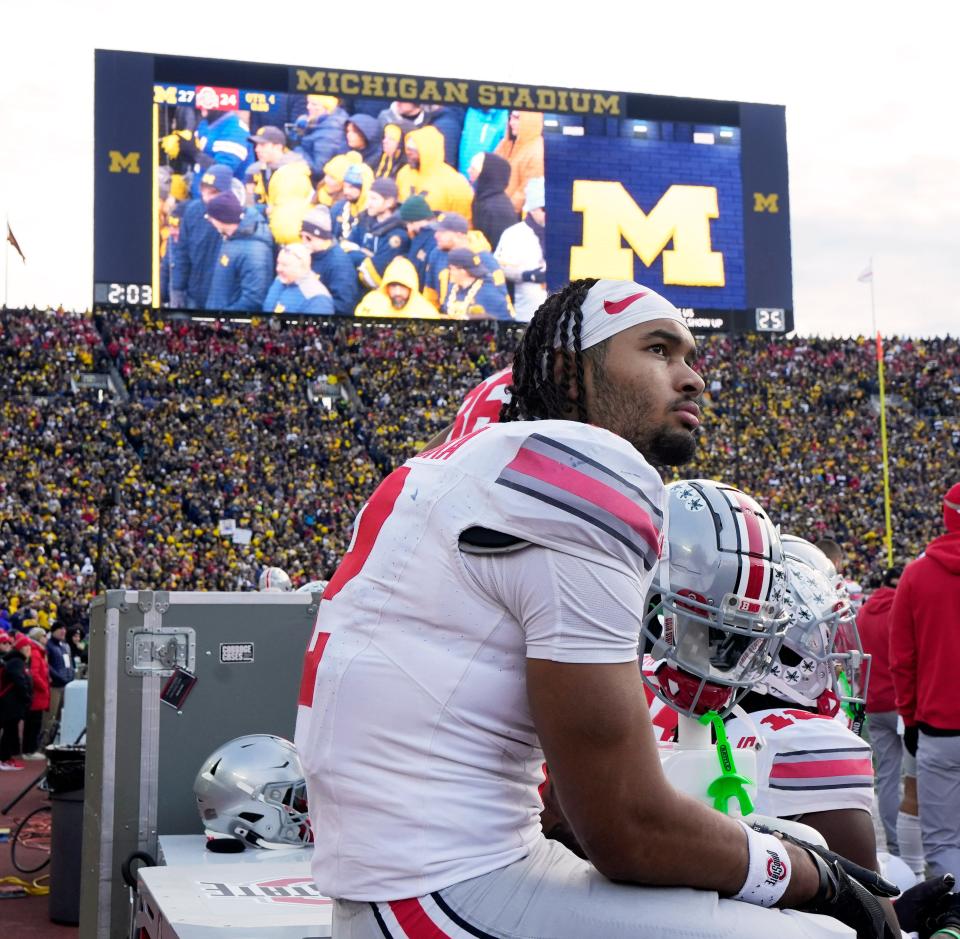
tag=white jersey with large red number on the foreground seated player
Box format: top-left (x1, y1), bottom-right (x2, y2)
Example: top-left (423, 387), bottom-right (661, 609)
top-left (296, 421), bottom-right (665, 901)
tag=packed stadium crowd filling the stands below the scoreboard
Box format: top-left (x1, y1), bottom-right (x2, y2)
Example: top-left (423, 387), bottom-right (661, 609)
top-left (0, 311), bottom-right (960, 626)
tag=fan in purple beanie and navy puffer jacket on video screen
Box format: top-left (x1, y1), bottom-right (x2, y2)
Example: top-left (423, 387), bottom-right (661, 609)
top-left (204, 192), bottom-right (273, 313)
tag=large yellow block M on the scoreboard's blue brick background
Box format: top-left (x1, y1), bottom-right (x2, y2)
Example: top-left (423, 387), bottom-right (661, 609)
top-left (570, 179), bottom-right (726, 287)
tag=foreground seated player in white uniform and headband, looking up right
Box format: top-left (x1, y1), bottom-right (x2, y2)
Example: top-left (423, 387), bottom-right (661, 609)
top-left (296, 281), bottom-right (896, 939)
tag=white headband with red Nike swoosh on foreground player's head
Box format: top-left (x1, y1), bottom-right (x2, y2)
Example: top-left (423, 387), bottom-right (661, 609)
top-left (553, 280), bottom-right (686, 350)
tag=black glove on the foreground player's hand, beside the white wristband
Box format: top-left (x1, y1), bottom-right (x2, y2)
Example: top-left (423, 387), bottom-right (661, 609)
top-left (753, 824), bottom-right (899, 939)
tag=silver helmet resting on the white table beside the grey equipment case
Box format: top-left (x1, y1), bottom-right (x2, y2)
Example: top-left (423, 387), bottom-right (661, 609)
top-left (193, 734), bottom-right (313, 848)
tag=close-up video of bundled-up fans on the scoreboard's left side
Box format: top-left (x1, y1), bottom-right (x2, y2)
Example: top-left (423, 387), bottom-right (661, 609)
top-left (158, 94), bottom-right (546, 320)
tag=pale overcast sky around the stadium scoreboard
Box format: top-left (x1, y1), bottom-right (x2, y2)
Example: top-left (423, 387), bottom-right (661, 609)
top-left (0, 0), bottom-right (960, 335)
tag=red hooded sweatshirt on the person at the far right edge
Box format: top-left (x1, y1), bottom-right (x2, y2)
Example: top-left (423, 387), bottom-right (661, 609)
top-left (890, 532), bottom-right (960, 730)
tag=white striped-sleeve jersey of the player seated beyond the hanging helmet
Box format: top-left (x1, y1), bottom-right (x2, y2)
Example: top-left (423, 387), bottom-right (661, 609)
top-left (727, 704), bottom-right (873, 818)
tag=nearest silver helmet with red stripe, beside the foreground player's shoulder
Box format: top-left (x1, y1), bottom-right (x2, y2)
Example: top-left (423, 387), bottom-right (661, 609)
top-left (642, 479), bottom-right (787, 717)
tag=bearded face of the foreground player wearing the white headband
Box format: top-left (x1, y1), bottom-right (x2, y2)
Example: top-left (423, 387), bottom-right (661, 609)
top-left (585, 319), bottom-right (704, 466)
